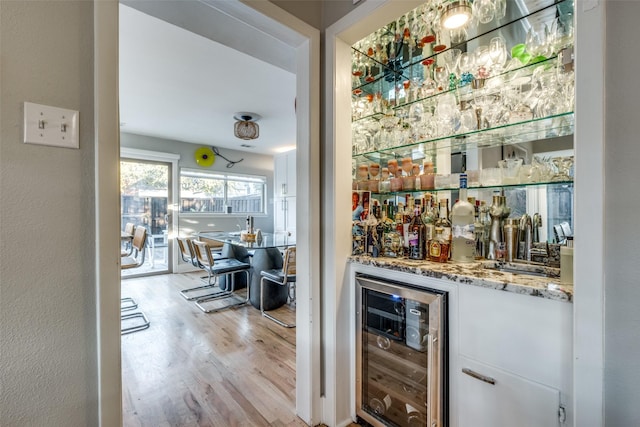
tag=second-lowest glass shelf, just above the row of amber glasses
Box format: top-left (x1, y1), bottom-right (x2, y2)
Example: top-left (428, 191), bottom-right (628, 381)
top-left (352, 112), bottom-right (574, 163)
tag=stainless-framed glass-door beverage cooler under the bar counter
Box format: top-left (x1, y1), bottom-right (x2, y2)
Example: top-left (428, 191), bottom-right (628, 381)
top-left (356, 275), bottom-right (448, 427)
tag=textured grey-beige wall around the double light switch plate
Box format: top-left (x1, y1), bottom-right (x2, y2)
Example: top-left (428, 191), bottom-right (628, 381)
top-left (0, 1), bottom-right (99, 427)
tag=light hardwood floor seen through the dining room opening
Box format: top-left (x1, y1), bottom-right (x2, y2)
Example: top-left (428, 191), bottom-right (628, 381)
top-left (122, 273), bottom-right (306, 427)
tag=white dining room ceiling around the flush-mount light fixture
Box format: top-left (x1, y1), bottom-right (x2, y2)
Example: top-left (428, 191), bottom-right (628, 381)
top-left (120, 2), bottom-right (296, 154)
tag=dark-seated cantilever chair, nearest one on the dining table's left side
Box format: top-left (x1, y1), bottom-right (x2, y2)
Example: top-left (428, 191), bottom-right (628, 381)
top-left (192, 240), bottom-right (251, 313)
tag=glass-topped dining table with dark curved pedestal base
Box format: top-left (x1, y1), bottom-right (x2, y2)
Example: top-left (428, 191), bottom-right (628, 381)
top-left (198, 232), bottom-right (296, 310)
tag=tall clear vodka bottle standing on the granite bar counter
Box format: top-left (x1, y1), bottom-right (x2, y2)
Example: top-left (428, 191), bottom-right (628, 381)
top-left (451, 173), bottom-right (476, 262)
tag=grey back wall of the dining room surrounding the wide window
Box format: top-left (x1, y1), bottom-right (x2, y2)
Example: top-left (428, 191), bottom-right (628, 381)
top-left (120, 133), bottom-right (274, 236)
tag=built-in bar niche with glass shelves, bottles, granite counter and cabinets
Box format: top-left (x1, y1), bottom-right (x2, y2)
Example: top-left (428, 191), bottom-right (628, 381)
top-left (349, 0), bottom-right (575, 427)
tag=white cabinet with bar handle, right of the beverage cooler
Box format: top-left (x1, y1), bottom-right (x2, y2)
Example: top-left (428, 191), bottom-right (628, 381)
top-left (458, 286), bottom-right (572, 427)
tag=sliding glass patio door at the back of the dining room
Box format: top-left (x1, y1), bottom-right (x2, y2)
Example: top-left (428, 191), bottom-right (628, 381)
top-left (120, 158), bottom-right (172, 278)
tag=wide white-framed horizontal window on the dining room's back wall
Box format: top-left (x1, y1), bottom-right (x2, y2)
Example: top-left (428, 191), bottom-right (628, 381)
top-left (180, 169), bottom-right (266, 214)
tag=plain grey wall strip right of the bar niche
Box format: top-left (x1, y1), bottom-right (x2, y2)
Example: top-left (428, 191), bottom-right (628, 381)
top-left (604, 1), bottom-right (640, 426)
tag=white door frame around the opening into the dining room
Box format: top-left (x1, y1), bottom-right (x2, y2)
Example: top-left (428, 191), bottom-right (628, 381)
top-left (94, 0), bottom-right (322, 427)
